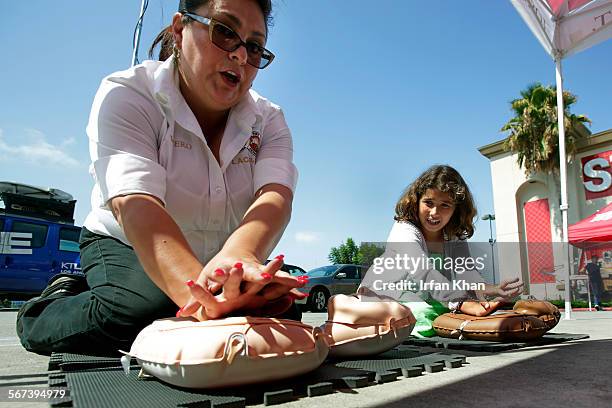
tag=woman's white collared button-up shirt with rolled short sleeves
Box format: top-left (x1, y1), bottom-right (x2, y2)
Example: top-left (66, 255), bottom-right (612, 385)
top-left (84, 58), bottom-right (297, 263)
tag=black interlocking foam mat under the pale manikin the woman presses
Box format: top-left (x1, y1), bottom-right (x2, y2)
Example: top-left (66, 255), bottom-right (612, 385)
top-left (49, 346), bottom-right (466, 408)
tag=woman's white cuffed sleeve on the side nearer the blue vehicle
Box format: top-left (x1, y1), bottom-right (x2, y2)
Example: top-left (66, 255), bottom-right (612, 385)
top-left (87, 79), bottom-right (166, 206)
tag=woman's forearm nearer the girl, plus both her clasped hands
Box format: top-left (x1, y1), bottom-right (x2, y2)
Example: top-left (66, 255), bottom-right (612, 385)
top-left (177, 183), bottom-right (296, 320)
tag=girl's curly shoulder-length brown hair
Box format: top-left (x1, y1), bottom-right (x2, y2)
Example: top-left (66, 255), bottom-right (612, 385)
top-left (393, 165), bottom-right (476, 239)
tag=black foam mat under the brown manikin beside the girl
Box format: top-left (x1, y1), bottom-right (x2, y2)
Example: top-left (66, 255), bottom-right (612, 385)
top-left (403, 333), bottom-right (589, 352)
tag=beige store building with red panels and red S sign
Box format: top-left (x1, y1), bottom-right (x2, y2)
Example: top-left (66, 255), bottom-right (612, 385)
top-left (478, 129), bottom-right (612, 299)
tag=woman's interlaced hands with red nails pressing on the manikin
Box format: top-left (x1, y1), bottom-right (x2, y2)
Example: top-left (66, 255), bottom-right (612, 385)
top-left (177, 251), bottom-right (307, 320)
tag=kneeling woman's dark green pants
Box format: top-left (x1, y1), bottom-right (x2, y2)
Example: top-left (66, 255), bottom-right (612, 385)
top-left (17, 228), bottom-right (301, 355)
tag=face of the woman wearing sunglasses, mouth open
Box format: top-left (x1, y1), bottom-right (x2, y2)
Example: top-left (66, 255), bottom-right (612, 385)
top-left (173, 0), bottom-right (266, 112)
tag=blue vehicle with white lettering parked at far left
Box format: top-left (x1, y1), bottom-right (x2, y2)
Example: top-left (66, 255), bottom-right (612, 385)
top-left (0, 182), bottom-right (82, 299)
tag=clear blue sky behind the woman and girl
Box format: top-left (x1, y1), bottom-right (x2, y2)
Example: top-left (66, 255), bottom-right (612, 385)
top-left (0, 0), bottom-right (612, 269)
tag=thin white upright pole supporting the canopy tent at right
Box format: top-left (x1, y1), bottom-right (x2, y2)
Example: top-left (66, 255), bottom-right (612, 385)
top-left (555, 56), bottom-right (572, 320)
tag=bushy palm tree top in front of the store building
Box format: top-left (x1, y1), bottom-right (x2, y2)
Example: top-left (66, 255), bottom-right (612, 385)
top-left (501, 83), bottom-right (591, 175)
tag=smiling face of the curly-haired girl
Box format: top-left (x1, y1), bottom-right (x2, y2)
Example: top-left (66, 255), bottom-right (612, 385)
top-left (419, 188), bottom-right (455, 241)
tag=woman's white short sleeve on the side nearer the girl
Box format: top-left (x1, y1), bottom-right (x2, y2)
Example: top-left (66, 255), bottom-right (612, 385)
top-left (253, 107), bottom-right (298, 192)
